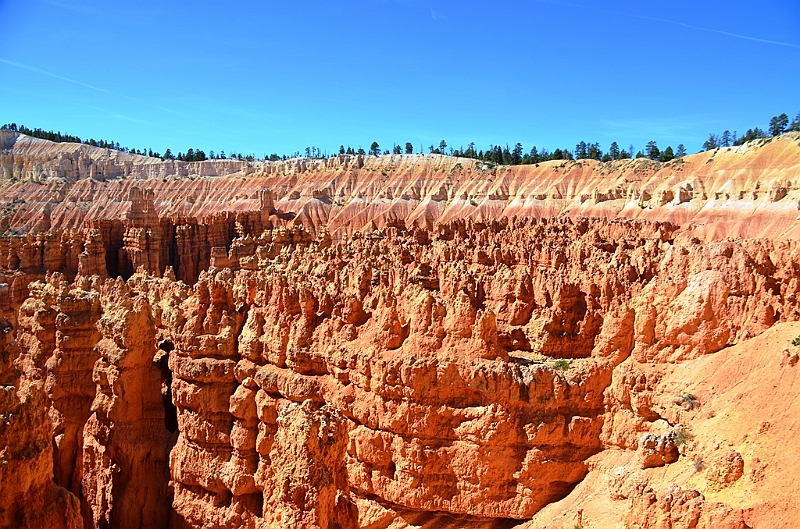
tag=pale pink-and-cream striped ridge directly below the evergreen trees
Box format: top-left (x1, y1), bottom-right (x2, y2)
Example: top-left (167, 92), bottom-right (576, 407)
top-left (0, 132), bottom-right (800, 241)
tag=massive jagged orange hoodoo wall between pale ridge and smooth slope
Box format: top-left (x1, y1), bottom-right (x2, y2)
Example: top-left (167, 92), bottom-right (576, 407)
top-left (1, 212), bottom-right (800, 527)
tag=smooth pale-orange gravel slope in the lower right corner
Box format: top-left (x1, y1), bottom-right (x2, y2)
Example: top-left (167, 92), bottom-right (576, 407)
top-left (522, 322), bottom-right (800, 529)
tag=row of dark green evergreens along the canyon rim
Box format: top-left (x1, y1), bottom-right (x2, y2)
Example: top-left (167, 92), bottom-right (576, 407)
top-left (0, 113), bottom-right (800, 165)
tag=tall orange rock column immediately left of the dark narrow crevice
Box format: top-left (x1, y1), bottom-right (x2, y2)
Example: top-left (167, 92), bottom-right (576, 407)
top-left (82, 289), bottom-right (171, 529)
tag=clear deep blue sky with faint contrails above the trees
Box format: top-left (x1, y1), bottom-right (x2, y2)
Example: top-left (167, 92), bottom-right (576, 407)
top-left (0, 0), bottom-right (800, 156)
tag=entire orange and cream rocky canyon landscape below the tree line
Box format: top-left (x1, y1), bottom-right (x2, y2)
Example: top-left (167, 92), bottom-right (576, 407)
top-left (0, 131), bottom-right (800, 529)
